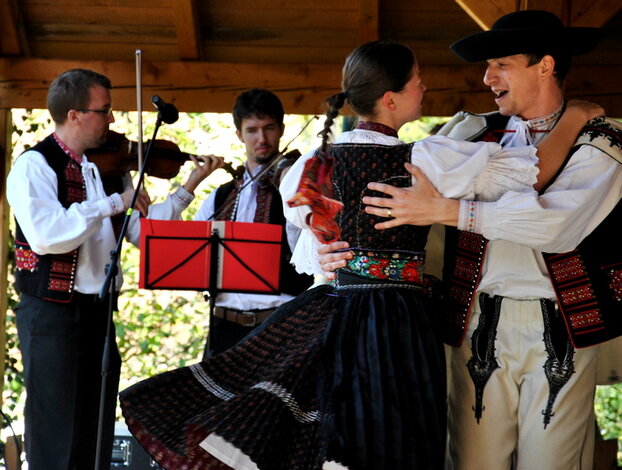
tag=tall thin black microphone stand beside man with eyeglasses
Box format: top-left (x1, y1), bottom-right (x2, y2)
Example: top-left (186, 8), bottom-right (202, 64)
top-left (95, 112), bottom-right (170, 470)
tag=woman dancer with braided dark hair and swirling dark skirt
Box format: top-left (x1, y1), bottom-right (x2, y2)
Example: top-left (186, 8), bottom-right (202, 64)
top-left (121, 41), bottom-right (604, 470)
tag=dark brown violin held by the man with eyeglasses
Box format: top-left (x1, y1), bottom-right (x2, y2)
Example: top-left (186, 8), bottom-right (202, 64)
top-left (85, 130), bottom-right (244, 179)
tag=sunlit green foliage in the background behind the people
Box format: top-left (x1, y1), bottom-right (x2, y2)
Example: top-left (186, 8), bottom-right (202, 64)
top-left (2, 110), bottom-right (622, 463)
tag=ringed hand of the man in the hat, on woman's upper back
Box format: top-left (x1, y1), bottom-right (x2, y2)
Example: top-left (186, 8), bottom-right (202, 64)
top-left (363, 163), bottom-right (460, 230)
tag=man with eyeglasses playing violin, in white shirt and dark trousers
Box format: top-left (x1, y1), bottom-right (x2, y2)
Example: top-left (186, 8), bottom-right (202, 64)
top-left (7, 69), bottom-right (213, 470)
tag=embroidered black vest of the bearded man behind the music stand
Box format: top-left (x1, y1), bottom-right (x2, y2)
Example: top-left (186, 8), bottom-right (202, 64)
top-left (214, 169), bottom-right (313, 295)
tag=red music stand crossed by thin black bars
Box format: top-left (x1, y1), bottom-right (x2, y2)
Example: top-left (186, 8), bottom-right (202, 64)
top-left (139, 219), bottom-right (282, 351)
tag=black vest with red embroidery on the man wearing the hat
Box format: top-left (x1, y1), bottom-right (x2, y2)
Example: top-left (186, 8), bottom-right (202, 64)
top-left (443, 113), bottom-right (622, 347)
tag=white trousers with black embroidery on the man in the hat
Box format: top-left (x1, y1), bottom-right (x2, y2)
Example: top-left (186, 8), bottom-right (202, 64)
top-left (448, 299), bottom-right (598, 470)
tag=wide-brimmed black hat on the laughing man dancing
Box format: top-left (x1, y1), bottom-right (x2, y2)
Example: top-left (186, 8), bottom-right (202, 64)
top-left (450, 10), bottom-right (601, 62)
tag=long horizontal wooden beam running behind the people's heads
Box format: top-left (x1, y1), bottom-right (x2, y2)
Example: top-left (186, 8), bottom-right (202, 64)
top-left (0, 58), bottom-right (622, 117)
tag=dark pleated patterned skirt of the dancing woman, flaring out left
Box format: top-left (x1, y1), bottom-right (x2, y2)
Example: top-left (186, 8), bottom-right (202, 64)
top-left (120, 286), bottom-right (446, 470)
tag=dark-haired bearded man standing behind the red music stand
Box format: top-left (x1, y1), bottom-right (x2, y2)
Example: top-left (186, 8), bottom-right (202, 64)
top-left (195, 88), bottom-right (312, 356)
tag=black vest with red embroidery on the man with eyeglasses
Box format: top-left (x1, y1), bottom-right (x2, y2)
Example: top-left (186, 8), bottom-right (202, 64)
top-left (15, 135), bottom-right (86, 302)
